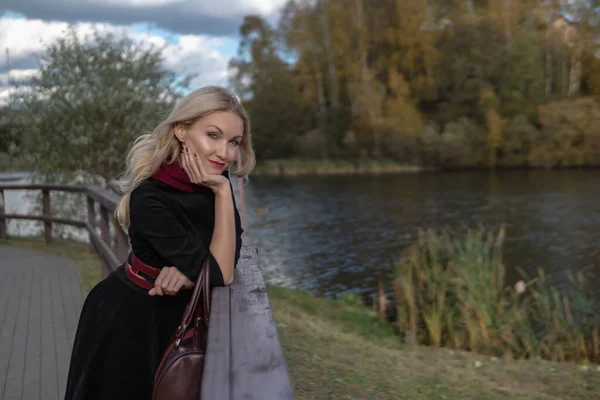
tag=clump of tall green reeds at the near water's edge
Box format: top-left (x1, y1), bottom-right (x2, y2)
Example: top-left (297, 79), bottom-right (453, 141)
top-left (394, 228), bottom-right (600, 362)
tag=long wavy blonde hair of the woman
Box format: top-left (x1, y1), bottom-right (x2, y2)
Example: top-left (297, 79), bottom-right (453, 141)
top-left (113, 86), bottom-right (256, 232)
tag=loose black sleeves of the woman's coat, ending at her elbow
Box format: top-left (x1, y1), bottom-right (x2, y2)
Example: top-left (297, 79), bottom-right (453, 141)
top-left (130, 188), bottom-right (243, 286)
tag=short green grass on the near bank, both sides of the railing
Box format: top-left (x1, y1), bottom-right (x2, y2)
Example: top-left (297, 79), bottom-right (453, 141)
top-left (2, 239), bottom-right (600, 400)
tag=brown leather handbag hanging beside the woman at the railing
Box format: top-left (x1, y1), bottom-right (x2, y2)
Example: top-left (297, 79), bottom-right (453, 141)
top-left (152, 258), bottom-right (210, 400)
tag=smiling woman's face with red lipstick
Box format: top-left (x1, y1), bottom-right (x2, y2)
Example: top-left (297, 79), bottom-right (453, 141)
top-left (175, 111), bottom-right (244, 175)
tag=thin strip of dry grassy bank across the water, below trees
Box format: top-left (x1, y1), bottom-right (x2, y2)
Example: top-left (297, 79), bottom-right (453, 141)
top-left (252, 158), bottom-right (424, 176)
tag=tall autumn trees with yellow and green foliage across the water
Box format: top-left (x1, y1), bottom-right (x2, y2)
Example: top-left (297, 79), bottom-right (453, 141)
top-left (230, 0), bottom-right (600, 167)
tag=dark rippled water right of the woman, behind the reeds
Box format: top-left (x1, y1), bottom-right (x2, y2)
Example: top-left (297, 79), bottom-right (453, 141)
top-left (244, 170), bottom-right (600, 295)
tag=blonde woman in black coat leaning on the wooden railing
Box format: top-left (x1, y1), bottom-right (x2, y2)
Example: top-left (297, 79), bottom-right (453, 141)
top-left (65, 86), bottom-right (255, 400)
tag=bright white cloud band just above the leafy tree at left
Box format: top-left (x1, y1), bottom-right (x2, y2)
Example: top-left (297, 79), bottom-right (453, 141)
top-left (0, 18), bottom-right (234, 103)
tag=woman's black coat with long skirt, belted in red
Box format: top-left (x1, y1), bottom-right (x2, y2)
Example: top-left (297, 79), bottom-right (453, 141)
top-left (65, 171), bottom-right (242, 400)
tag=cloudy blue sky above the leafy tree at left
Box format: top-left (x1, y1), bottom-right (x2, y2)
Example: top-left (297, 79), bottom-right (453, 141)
top-left (0, 0), bottom-right (286, 103)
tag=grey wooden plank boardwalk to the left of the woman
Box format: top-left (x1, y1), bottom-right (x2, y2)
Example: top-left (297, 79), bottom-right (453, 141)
top-left (0, 245), bottom-right (85, 400)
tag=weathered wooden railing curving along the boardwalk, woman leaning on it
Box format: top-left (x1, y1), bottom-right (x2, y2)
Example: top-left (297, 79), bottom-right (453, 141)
top-left (0, 184), bottom-right (293, 400)
